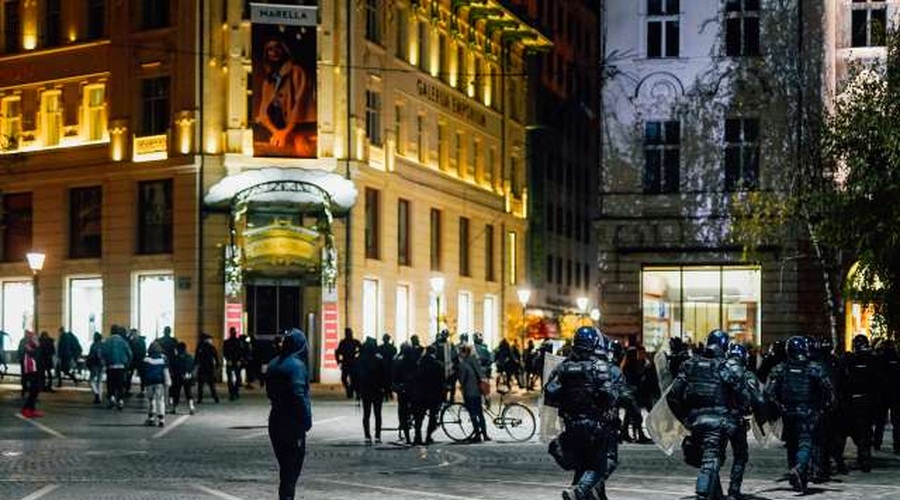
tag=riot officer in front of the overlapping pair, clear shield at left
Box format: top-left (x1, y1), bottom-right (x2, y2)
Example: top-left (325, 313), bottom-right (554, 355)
top-left (667, 329), bottom-right (743, 500)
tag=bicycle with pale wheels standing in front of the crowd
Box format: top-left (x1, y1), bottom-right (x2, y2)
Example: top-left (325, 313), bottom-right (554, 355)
top-left (440, 389), bottom-right (536, 443)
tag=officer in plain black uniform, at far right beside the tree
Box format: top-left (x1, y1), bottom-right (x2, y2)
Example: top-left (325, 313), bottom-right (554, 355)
top-left (841, 335), bottom-right (884, 472)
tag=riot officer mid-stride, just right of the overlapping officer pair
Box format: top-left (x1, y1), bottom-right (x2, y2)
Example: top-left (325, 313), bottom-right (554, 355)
top-left (766, 336), bottom-right (834, 493)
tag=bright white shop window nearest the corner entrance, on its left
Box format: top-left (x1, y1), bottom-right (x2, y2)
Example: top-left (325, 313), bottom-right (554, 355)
top-left (132, 273), bottom-right (175, 340)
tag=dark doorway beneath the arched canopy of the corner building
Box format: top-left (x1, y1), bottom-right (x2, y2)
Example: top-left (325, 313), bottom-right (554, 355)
top-left (245, 280), bottom-right (304, 340)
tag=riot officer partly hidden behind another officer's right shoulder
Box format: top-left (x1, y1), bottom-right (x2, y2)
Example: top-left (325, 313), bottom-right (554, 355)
top-left (725, 342), bottom-right (765, 500)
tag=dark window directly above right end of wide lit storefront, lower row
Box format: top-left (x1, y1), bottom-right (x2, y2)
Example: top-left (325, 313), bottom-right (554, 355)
top-left (725, 118), bottom-right (759, 191)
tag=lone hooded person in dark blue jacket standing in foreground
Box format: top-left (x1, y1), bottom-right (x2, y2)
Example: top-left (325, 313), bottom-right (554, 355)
top-left (266, 328), bottom-right (312, 500)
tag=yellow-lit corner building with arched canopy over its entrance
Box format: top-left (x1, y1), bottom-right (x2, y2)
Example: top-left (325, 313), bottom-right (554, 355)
top-left (0, 0), bottom-right (549, 381)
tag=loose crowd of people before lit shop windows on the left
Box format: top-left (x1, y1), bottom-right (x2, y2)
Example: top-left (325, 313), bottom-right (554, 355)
top-left (10, 325), bottom-right (268, 427)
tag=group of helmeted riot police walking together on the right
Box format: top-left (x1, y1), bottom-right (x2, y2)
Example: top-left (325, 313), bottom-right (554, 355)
top-left (544, 327), bottom-right (900, 500)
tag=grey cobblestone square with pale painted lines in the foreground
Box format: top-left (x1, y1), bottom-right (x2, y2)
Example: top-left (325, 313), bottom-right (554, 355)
top-left (0, 385), bottom-right (900, 500)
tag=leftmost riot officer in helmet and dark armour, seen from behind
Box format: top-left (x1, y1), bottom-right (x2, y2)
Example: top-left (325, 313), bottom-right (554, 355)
top-left (545, 326), bottom-right (622, 500)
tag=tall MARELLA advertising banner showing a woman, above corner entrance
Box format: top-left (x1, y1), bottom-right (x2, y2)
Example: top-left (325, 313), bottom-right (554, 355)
top-left (250, 4), bottom-right (317, 158)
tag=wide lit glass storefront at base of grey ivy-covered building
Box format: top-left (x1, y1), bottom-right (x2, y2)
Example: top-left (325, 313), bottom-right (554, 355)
top-left (641, 266), bottom-right (761, 351)
